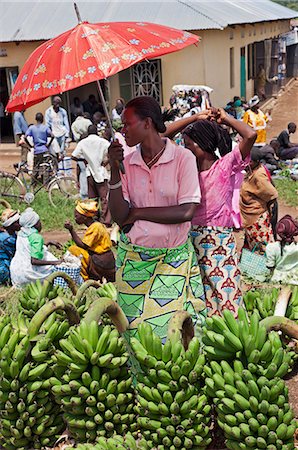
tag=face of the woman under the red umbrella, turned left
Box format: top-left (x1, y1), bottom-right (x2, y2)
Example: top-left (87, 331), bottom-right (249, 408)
top-left (122, 108), bottom-right (150, 147)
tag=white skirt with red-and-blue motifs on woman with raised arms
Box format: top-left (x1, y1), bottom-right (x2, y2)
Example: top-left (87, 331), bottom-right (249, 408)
top-left (191, 225), bottom-right (242, 317)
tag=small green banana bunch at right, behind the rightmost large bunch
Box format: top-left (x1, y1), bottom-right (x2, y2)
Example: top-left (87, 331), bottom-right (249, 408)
top-left (243, 288), bottom-right (279, 319)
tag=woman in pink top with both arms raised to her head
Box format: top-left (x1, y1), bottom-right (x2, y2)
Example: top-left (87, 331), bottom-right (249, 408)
top-left (183, 108), bottom-right (256, 316)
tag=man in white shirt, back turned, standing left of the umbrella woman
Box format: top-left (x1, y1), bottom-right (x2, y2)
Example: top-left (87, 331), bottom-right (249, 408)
top-left (72, 125), bottom-right (112, 227)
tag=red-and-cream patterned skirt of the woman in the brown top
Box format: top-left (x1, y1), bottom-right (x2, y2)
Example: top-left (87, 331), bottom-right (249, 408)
top-left (245, 211), bottom-right (274, 254)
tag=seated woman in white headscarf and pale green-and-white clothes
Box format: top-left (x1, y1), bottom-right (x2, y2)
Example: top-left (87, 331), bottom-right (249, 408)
top-left (10, 208), bottom-right (62, 287)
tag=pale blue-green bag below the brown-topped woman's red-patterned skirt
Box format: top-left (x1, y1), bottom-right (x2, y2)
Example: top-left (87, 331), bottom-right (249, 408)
top-left (239, 248), bottom-right (270, 281)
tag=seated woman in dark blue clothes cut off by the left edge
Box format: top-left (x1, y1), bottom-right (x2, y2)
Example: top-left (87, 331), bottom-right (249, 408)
top-left (0, 209), bottom-right (21, 284)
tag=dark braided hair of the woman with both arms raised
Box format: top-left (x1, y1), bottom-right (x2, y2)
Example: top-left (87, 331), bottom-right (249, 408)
top-left (183, 120), bottom-right (232, 156)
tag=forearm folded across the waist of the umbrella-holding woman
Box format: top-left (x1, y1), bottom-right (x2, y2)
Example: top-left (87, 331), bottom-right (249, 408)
top-left (124, 203), bottom-right (197, 224)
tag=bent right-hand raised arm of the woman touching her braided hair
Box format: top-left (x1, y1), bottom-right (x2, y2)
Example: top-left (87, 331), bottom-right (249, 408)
top-left (216, 108), bottom-right (257, 160)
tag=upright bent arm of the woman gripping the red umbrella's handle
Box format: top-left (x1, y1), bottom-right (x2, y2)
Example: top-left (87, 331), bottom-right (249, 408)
top-left (109, 140), bottom-right (129, 227)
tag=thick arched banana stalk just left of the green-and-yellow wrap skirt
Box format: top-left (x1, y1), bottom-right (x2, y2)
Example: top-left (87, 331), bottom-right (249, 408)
top-left (84, 297), bottom-right (128, 333)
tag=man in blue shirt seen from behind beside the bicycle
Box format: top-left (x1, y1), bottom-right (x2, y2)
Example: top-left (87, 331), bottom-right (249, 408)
top-left (25, 113), bottom-right (54, 184)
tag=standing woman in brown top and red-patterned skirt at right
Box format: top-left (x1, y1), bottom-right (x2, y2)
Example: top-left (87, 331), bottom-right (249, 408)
top-left (240, 156), bottom-right (278, 253)
